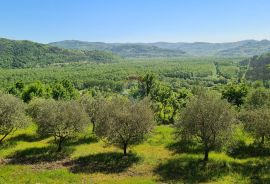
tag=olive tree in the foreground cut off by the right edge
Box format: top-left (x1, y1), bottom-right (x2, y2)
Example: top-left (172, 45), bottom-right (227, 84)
top-left (239, 107), bottom-right (270, 145)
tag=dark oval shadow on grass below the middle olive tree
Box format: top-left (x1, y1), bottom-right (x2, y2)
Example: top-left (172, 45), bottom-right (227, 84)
top-left (68, 152), bottom-right (140, 174)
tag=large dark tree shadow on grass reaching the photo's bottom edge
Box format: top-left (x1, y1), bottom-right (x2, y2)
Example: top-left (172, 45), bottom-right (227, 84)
top-left (154, 158), bottom-right (229, 183)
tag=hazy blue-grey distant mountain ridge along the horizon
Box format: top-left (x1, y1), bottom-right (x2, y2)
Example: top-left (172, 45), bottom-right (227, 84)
top-left (50, 40), bottom-right (270, 57)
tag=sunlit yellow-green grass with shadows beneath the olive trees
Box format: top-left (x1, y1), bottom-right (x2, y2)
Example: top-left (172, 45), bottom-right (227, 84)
top-left (0, 125), bottom-right (270, 184)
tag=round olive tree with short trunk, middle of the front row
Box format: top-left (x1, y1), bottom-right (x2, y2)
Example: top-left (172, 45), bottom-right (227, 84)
top-left (95, 97), bottom-right (154, 155)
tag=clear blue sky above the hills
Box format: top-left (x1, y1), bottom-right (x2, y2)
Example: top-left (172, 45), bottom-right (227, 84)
top-left (0, 0), bottom-right (270, 43)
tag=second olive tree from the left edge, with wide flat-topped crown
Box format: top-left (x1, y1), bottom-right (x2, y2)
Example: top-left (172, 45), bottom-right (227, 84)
top-left (30, 99), bottom-right (89, 151)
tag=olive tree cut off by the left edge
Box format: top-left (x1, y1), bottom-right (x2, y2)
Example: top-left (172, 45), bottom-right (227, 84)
top-left (0, 94), bottom-right (29, 143)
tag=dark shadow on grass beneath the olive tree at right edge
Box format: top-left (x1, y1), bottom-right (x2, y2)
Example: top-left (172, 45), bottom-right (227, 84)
top-left (227, 141), bottom-right (270, 158)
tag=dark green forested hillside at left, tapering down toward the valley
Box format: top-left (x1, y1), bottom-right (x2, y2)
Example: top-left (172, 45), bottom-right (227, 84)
top-left (0, 38), bottom-right (120, 68)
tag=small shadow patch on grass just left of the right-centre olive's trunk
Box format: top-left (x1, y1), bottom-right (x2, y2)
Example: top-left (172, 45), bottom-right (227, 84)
top-left (167, 140), bottom-right (203, 153)
